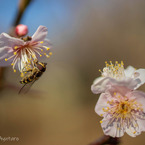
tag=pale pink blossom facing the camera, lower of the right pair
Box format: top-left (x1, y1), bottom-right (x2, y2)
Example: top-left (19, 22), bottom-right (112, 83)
top-left (95, 86), bottom-right (145, 137)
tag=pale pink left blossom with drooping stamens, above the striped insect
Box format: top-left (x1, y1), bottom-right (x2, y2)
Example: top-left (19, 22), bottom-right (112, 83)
top-left (0, 26), bottom-right (52, 72)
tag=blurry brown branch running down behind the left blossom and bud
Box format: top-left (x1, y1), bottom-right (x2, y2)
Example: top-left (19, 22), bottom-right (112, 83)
top-left (0, 0), bottom-right (32, 90)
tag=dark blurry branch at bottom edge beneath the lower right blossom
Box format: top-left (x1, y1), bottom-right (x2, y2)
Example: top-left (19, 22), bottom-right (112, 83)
top-left (89, 135), bottom-right (120, 145)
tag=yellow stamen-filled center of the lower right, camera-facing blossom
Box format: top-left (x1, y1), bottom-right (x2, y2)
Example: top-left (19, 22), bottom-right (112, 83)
top-left (103, 93), bottom-right (143, 120)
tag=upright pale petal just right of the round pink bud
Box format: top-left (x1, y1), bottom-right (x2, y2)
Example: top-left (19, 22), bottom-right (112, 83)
top-left (32, 26), bottom-right (48, 42)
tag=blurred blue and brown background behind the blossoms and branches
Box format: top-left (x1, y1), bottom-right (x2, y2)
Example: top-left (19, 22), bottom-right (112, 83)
top-left (0, 0), bottom-right (145, 145)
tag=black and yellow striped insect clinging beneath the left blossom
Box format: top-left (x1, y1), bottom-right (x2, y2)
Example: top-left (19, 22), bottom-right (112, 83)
top-left (19, 61), bottom-right (47, 94)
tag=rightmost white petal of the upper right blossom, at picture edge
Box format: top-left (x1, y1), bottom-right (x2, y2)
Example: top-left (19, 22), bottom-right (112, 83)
top-left (135, 69), bottom-right (145, 89)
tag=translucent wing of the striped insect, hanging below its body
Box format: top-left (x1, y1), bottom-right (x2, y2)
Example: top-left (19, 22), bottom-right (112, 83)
top-left (18, 80), bottom-right (36, 94)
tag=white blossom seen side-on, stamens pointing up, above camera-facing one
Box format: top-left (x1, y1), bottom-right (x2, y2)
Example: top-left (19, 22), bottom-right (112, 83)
top-left (91, 61), bottom-right (145, 94)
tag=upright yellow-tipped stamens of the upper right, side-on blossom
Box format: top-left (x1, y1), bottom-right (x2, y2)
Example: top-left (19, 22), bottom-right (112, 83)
top-left (99, 61), bottom-right (125, 80)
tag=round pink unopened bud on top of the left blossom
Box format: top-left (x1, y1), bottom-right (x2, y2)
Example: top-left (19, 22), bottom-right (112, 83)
top-left (15, 24), bottom-right (28, 37)
